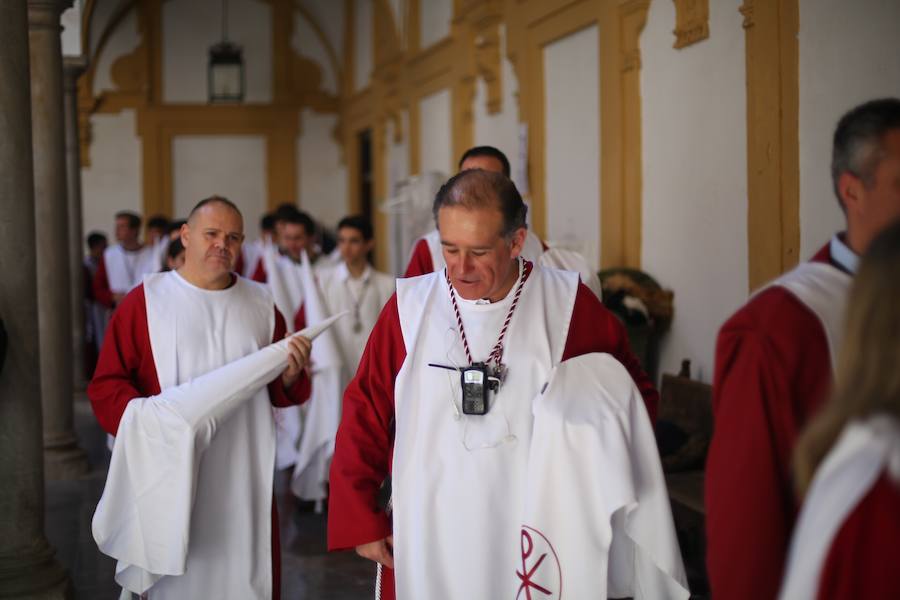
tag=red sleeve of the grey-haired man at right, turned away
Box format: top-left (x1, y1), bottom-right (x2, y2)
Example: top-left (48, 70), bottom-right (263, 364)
top-left (705, 288), bottom-right (830, 600)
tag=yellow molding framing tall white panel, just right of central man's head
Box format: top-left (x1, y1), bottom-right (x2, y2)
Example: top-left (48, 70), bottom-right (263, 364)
top-left (504, 0), bottom-right (649, 267)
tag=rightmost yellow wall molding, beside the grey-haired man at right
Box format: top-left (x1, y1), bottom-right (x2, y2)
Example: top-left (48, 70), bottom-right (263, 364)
top-left (740, 0), bottom-right (800, 290)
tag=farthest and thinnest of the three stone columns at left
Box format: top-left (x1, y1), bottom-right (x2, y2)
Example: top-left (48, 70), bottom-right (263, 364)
top-left (63, 57), bottom-right (86, 393)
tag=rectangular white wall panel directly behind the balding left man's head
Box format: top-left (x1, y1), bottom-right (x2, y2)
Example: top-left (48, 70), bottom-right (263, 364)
top-left (172, 135), bottom-right (266, 239)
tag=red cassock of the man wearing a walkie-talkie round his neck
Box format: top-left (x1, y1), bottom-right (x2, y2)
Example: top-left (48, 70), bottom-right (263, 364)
top-left (328, 284), bottom-right (659, 600)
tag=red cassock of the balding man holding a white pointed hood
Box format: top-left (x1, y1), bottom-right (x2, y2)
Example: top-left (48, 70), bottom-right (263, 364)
top-left (87, 284), bottom-right (310, 600)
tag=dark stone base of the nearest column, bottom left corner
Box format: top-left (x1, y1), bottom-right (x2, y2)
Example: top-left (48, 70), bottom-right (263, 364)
top-left (0, 540), bottom-right (74, 600)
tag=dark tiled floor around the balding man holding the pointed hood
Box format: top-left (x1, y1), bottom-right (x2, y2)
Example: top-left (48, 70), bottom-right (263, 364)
top-left (46, 402), bottom-right (375, 600)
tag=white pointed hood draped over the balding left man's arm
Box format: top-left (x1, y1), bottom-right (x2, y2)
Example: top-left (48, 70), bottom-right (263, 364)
top-left (92, 314), bottom-right (344, 594)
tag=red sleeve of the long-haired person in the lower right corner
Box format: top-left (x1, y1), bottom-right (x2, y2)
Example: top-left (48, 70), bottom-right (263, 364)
top-left (816, 473), bottom-right (900, 600)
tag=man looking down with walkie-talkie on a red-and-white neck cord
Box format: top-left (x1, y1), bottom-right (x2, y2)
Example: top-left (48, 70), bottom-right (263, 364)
top-left (328, 169), bottom-right (687, 598)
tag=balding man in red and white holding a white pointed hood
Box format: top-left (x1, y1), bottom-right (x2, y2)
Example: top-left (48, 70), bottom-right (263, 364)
top-left (88, 197), bottom-right (310, 599)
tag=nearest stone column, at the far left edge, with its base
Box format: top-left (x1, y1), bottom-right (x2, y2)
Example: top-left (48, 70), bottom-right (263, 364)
top-left (0, 1), bottom-right (70, 598)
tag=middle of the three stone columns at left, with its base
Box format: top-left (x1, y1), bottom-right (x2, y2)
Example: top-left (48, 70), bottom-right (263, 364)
top-left (28, 0), bottom-right (88, 479)
